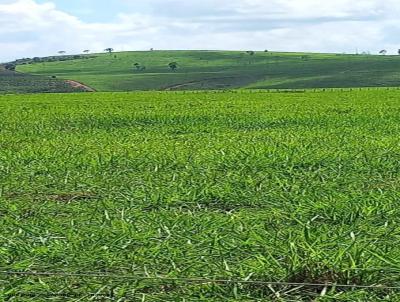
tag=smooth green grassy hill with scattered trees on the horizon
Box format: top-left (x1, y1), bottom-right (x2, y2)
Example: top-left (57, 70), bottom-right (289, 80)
top-left (18, 51), bottom-right (400, 91)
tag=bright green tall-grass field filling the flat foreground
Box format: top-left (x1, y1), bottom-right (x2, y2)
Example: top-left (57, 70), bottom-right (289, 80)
top-left (0, 90), bottom-right (400, 301)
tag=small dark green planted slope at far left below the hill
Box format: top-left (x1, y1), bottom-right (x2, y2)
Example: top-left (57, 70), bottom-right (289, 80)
top-left (0, 66), bottom-right (85, 94)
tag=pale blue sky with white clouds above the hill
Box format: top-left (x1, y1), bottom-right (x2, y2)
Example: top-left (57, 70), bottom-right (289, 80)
top-left (0, 0), bottom-right (400, 62)
